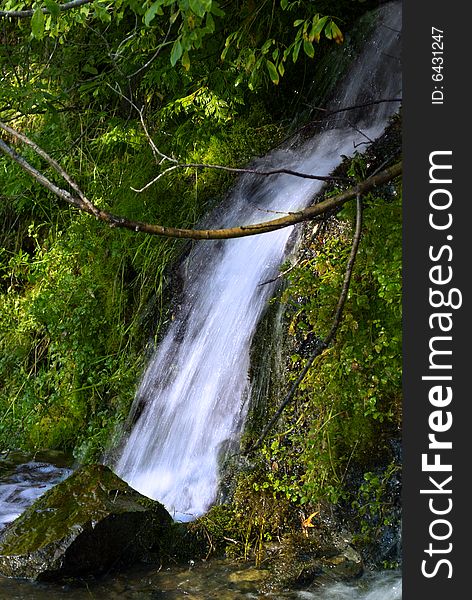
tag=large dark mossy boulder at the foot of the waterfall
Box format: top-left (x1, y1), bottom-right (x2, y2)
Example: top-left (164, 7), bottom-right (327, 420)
top-left (0, 465), bottom-right (172, 580)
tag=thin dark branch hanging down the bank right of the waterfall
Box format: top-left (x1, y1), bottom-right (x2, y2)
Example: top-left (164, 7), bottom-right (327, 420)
top-left (243, 193), bottom-right (362, 455)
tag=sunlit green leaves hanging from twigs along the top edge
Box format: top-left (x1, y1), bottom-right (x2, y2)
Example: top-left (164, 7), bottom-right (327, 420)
top-left (2, 0), bottom-right (343, 90)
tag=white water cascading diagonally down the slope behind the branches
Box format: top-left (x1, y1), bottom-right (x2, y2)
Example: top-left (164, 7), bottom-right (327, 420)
top-left (114, 3), bottom-right (401, 519)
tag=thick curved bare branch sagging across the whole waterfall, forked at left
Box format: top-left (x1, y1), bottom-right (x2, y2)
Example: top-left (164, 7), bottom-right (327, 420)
top-left (0, 125), bottom-right (402, 240)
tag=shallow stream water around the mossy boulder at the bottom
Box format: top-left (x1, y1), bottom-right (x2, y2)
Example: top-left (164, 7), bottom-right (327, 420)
top-left (0, 452), bottom-right (401, 600)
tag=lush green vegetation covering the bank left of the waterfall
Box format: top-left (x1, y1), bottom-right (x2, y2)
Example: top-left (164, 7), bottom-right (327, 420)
top-left (0, 1), bottom-right (296, 459)
